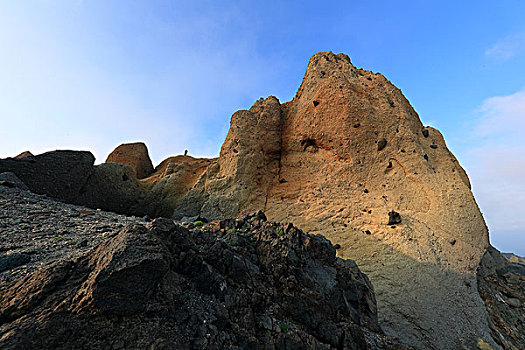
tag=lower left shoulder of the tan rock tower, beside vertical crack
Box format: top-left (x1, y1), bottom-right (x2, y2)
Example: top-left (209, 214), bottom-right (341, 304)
top-left (174, 96), bottom-right (282, 218)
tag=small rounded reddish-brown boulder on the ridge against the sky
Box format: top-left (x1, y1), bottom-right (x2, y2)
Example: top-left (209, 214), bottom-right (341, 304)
top-left (106, 142), bottom-right (153, 179)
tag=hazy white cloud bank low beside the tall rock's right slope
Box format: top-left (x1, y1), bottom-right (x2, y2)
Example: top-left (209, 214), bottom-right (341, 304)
top-left (462, 89), bottom-right (525, 254)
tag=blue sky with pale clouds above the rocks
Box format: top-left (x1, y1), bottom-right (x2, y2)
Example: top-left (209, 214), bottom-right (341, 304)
top-left (0, 0), bottom-right (525, 255)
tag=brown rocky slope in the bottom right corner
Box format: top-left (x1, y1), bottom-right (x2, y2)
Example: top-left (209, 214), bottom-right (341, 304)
top-left (477, 247), bottom-right (525, 349)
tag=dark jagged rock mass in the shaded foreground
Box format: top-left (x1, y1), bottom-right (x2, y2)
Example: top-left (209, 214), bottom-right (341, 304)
top-left (0, 189), bottom-right (406, 350)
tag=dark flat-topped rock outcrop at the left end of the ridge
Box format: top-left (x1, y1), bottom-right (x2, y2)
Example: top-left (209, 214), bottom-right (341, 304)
top-left (0, 151), bottom-right (95, 202)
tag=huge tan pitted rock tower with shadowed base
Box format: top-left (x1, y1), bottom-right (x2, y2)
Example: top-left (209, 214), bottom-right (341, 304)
top-left (175, 52), bottom-right (497, 349)
